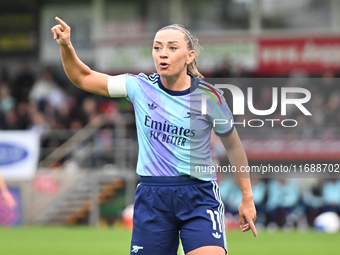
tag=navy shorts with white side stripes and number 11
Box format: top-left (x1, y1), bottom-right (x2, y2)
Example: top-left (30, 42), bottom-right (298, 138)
top-left (130, 176), bottom-right (227, 255)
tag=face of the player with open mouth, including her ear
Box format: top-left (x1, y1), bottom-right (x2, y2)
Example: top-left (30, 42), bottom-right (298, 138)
top-left (152, 29), bottom-right (195, 77)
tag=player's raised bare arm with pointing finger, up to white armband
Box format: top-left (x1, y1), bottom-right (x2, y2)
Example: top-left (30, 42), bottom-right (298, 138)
top-left (51, 17), bottom-right (110, 96)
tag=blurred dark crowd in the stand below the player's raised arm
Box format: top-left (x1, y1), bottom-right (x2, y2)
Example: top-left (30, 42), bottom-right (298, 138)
top-left (0, 64), bottom-right (133, 163)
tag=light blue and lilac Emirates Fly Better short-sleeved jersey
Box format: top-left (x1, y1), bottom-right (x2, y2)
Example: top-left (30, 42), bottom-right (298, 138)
top-left (109, 74), bottom-right (234, 181)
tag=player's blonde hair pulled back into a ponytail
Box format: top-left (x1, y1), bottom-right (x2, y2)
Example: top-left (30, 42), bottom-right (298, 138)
top-left (158, 24), bottom-right (204, 79)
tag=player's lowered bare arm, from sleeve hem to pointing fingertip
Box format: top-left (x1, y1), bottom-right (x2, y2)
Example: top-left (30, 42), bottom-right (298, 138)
top-left (221, 128), bottom-right (257, 237)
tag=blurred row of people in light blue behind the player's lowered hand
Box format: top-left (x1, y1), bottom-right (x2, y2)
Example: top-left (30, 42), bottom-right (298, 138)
top-left (220, 178), bottom-right (340, 229)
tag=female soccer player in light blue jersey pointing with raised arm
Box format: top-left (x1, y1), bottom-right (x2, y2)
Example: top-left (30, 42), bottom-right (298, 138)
top-left (52, 18), bottom-right (257, 255)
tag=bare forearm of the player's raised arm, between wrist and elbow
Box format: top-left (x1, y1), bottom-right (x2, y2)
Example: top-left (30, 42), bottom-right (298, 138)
top-left (60, 44), bottom-right (91, 89)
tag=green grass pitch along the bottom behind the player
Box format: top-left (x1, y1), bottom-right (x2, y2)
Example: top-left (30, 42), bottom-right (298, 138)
top-left (0, 227), bottom-right (340, 255)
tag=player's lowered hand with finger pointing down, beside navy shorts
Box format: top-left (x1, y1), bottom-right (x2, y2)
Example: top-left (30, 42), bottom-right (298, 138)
top-left (238, 199), bottom-right (257, 237)
